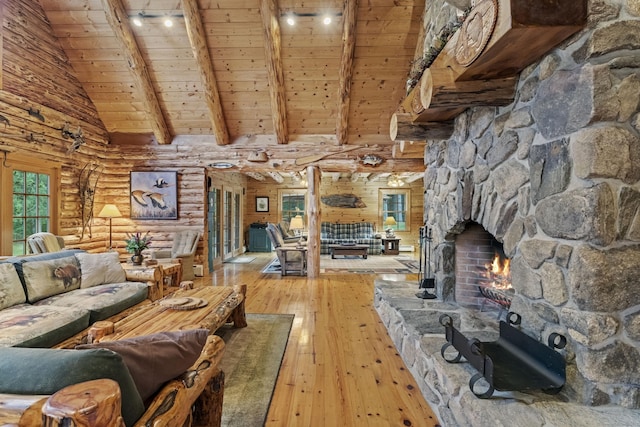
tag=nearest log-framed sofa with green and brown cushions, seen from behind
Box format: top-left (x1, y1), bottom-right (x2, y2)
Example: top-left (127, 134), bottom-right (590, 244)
top-left (0, 329), bottom-right (224, 427)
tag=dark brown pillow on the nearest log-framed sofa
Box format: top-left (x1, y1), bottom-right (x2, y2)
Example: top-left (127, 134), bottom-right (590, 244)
top-left (76, 329), bottom-right (209, 401)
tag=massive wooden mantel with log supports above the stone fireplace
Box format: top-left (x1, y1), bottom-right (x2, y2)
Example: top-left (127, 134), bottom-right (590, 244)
top-left (389, 0), bottom-right (587, 141)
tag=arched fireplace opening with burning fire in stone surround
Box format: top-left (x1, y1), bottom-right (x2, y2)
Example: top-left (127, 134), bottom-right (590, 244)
top-left (454, 223), bottom-right (513, 311)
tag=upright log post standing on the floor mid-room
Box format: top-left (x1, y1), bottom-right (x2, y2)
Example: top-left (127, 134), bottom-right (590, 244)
top-left (306, 166), bottom-right (321, 278)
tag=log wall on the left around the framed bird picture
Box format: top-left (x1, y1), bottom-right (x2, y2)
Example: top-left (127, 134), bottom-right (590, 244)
top-left (0, 0), bottom-right (205, 253)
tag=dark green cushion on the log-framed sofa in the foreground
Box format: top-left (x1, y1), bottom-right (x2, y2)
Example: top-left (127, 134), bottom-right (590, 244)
top-left (0, 347), bottom-right (145, 426)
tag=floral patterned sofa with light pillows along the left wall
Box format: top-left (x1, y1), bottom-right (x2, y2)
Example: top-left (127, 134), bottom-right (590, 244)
top-left (0, 250), bottom-right (154, 347)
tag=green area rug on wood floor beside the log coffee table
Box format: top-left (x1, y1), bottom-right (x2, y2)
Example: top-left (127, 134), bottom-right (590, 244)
top-left (216, 314), bottom-right (294, 427)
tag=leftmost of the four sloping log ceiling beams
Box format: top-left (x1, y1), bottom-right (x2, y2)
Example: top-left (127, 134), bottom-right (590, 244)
top-left (102, 0), bottom-right (172, 144)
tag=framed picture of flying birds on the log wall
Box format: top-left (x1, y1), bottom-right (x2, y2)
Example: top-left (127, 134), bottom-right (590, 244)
top-left (129, 172), bottom-right (178, 219)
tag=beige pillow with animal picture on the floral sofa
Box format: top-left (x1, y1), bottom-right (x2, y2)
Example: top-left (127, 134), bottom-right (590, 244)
top-left (22, 255), bottom-right (82, 303)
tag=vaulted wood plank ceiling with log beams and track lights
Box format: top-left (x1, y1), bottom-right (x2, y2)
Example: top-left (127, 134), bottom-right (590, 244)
top-left (40, 0), bottom-right (425, 176)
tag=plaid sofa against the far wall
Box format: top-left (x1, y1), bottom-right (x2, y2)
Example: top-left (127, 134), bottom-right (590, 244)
top-left (320, 221), bottom-right (382, 255)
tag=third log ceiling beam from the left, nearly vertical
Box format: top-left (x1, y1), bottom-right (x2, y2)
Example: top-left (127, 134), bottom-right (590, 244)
top-left (260, 0), bottom-right (289, 144)
